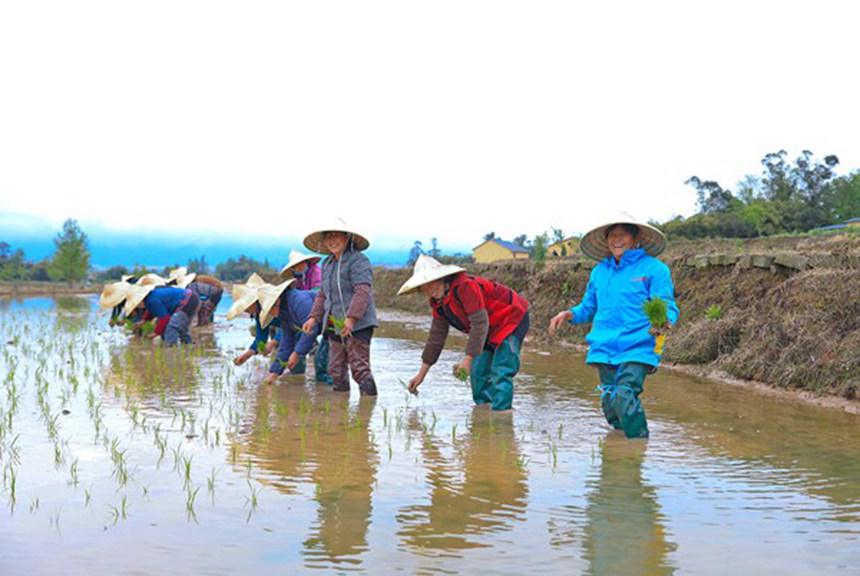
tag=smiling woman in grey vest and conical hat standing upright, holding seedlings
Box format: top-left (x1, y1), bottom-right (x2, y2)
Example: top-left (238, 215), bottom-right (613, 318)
top-left (302, 218), bottom-right (378, 396)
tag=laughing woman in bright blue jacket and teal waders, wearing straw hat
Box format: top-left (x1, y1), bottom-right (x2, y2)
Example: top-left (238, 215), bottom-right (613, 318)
top-left (549, 216), bottom-right (679, 438)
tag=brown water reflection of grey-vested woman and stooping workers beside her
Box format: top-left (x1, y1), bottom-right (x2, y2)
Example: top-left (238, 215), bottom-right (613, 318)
top-left (242, 384), bottom-right (379, 568)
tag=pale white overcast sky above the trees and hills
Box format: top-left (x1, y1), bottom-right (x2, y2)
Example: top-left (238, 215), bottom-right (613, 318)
top-left (0, 0), bottom-right (860, 254)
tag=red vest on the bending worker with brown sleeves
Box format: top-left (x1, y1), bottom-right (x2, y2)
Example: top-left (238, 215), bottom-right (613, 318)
top-left (430, 272), bottom-right (529, 348)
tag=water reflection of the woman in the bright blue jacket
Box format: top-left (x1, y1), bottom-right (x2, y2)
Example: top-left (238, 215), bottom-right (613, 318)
top-left (585, 434), bottom-right (675, 574)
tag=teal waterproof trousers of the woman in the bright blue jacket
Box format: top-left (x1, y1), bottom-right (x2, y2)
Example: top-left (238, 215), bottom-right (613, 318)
top-left (596, 362), bottom-right (654, 438)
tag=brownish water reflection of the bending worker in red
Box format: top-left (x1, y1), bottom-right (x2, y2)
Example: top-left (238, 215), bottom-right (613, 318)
top-left (398, 413), bottom-right (528, 551)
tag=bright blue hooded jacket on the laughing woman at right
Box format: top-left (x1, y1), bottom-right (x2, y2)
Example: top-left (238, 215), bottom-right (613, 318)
top-left (570, 248), bottom-right (680, 366)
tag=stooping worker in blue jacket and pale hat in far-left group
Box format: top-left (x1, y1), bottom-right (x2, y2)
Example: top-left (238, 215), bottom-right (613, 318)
top-left (125, 282), bottom-right (200, 346)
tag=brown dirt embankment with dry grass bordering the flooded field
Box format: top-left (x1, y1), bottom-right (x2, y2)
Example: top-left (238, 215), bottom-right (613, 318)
top-left (374, 234), bottom-right (860, 407)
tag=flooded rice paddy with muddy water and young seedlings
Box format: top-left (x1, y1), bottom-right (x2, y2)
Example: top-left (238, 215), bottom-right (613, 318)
top-left (0, 297), bottom-right (860, 574)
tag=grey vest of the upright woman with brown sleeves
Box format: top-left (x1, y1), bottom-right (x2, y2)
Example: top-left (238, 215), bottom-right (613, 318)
top-left (320, 250), bottom-right (378, 331)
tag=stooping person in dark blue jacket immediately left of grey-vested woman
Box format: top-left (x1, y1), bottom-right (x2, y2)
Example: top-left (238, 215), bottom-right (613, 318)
top-left (259, 280), bottom-right (319, 384)
